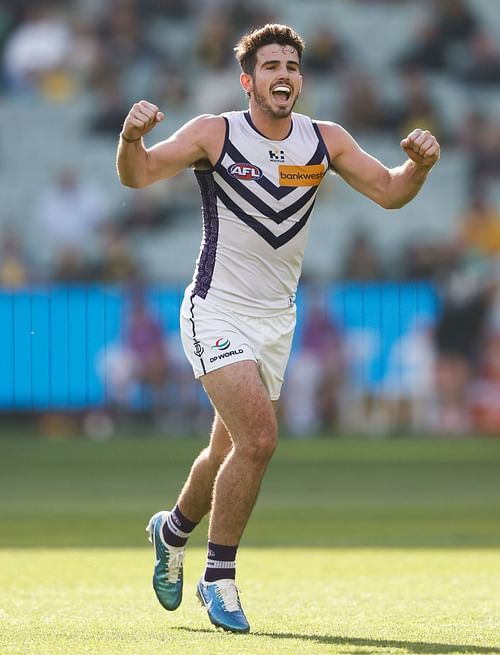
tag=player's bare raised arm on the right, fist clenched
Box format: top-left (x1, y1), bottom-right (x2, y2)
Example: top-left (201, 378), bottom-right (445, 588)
top-left (321, 123), bottom-right (440, 209)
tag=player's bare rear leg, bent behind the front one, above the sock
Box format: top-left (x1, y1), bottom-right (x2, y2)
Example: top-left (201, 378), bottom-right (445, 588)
top-left (178, 413), bottom-right (232, 523)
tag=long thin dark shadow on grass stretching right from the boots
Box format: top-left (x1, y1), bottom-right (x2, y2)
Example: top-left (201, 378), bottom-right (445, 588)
top-left (175, 626), bottom-right (500, 655)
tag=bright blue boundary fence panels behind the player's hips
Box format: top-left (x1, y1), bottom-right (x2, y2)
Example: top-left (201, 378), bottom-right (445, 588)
top-left (0, 283), bottom-right (438, 411)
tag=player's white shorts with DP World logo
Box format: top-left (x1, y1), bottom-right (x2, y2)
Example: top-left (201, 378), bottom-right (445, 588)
top-left (180, 294), bottom-right (296, 400)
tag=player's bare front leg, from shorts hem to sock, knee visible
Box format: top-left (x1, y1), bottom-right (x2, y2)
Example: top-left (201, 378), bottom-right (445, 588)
top-left (202, 361), bottom-right (278, 545)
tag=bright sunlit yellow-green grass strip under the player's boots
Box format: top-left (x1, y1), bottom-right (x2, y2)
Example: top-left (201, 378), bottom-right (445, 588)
top-left (0, 548), bottom-right (500, 655)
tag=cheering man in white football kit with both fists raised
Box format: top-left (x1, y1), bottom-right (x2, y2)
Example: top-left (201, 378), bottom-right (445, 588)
top-left (117, 25), bottom-right (439, 632)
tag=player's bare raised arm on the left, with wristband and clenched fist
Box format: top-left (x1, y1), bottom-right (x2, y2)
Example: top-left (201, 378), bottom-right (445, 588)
top-left (116, 100), bottom-right (223, 189)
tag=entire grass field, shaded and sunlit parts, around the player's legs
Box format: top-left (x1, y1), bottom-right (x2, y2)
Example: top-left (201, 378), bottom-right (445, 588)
top-left (0, 438), bottom-right (500, 655)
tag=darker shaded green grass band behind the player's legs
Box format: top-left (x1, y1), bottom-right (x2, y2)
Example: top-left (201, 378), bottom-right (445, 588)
top-left (0, 438), bottom-right (500, 548)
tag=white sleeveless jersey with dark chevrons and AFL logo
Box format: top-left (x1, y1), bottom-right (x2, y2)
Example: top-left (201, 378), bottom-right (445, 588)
top-left (187, 111), bottom-right (330, 316)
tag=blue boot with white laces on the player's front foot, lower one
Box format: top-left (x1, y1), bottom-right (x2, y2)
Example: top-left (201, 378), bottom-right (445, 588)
top-left (196, 578), bottom-right (250, 633)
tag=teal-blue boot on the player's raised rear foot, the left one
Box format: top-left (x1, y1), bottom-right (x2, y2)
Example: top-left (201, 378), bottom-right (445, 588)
top-left (146, 511), bottom-right (185, 611)
